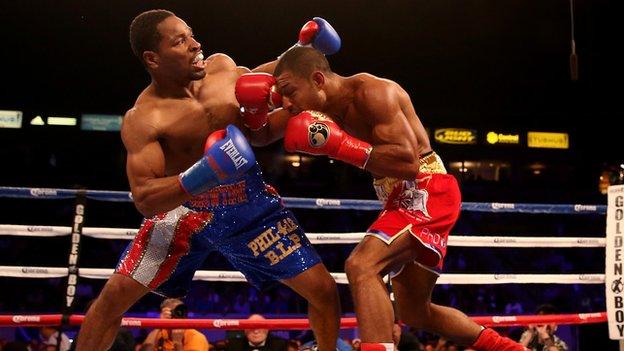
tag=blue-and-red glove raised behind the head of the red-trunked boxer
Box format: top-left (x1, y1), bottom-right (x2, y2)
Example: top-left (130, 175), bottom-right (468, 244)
top-left (297, 17), bottom-right (341, 55)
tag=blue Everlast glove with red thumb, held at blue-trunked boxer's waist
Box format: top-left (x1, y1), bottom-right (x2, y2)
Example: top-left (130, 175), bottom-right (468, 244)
top-left (179, 124), bottom-right (256, 195)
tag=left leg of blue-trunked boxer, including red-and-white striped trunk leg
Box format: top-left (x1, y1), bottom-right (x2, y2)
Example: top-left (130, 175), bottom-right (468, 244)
top-left (77, 206), bottom-right (212, 351)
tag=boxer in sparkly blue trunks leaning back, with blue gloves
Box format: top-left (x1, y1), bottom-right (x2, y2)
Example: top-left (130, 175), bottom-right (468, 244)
top-left (77, 10), bottom-right (340, 351)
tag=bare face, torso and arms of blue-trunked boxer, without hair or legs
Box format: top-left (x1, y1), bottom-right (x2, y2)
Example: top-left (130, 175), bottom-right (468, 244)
top-left (121, 16), bottom-right (275, 217)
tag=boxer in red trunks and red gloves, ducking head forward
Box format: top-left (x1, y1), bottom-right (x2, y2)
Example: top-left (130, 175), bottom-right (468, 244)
top-left (236, 48), bottom-right (525, 351)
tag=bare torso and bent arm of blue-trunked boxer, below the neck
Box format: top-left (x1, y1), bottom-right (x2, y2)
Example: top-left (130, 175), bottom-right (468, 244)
top-left (121, 54), bottom-right (242, 217)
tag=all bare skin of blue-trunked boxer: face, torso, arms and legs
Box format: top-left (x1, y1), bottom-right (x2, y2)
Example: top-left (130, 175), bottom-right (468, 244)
top-left (77, 16), bottom-right (340, 351)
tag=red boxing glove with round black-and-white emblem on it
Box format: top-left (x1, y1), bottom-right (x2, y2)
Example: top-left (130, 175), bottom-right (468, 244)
top-left (284, 111), bottom-right (373, 168)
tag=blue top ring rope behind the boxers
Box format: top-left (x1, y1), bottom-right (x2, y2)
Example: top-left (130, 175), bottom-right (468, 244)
top-left (0, 187), bottom-right (607, 214)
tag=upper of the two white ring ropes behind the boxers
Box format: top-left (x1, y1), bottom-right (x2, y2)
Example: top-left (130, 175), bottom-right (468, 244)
top-left (0, 224), bottom-right (606, 247)
